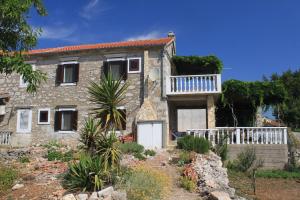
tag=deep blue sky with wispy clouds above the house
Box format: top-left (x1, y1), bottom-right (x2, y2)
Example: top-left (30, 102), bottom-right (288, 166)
top-left (30, 0), bottom-right (300, 81)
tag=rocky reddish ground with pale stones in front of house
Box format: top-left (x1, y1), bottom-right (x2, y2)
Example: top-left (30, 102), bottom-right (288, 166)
top-left (0, 147), bottom-right (244, 200)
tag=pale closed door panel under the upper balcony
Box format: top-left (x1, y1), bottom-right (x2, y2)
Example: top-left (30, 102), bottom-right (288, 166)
top-left (177, 109), bottom-right (206, 132)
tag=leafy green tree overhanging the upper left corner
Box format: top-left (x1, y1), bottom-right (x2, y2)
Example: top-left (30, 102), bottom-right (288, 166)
top-left (0, 0), bottom-right (47, 92)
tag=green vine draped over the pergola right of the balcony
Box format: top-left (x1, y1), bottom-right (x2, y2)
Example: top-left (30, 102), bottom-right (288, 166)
top-left (216, 80), bottom-right (287, 126)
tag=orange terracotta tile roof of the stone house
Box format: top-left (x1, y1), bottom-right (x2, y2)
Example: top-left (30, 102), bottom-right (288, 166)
top-left (27, 37), bottom-right (173, 55)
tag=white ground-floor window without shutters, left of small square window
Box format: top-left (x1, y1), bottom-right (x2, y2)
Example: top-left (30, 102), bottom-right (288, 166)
top-left (17, 109), bottom-right (32, 133)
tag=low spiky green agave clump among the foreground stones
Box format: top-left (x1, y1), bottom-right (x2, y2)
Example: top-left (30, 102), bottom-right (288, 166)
top-left (62, 155), bottom-right (109, 191)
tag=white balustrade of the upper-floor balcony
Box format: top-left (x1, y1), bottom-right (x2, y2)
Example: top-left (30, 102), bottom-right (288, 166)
top-left (167, 74), bottom-right (222, 95)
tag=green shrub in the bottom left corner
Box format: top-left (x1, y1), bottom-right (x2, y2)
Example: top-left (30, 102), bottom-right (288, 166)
top-left (0, 165), bottom-right (18, 193)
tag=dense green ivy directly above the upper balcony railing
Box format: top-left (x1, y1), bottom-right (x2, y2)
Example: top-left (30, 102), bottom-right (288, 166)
top-left (172, 55), bottom-right (223, 75)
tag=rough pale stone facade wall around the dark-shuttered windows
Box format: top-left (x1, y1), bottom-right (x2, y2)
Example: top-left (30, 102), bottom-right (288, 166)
top-left (0, 47), bottom-right (171, 146)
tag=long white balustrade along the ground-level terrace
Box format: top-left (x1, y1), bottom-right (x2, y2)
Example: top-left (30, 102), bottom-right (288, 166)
top-left (187, 127), bottom-right (287, 144)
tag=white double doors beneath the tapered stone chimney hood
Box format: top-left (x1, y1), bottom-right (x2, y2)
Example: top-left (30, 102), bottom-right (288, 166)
top-left (137, 122), bottom-right (163, 149)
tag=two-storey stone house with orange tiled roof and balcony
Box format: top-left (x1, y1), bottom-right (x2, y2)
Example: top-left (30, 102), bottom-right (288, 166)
top-left (0, 33), bottom-right (221, 147)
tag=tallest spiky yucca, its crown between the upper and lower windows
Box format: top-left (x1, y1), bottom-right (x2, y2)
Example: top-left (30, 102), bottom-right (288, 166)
top-left (88, 73), bottom-right (128, 132)
